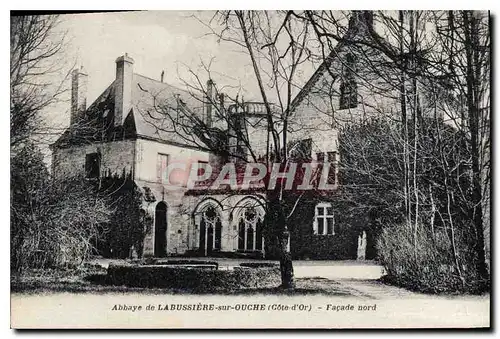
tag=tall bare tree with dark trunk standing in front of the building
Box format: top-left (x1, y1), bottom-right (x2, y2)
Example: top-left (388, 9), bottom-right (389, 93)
top-left (138, 11), bottom-right (320, 288)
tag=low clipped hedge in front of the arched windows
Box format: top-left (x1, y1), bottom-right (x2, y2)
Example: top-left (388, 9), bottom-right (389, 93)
top-left (108, 264), bottom-right (281, 292)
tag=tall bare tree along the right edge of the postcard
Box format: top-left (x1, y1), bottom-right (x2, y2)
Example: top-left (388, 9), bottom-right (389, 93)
top-left (432, 11), bottom-right (491, 279)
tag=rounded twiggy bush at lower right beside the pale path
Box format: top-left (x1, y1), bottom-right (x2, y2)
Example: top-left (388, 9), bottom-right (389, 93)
top-left (377, 224), bottom-right (485, 293)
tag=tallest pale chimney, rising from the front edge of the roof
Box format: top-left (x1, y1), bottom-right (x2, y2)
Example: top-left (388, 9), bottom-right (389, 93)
top-left (115, 53), bottom-right (134, 126)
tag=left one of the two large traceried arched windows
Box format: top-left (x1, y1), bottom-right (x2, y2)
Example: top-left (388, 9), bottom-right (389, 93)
top-left (199, 206), bottom-right (222, 255)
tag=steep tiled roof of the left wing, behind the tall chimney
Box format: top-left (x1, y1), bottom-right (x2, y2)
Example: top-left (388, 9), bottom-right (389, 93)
top-left (52, 73), bottom-right (203, 147)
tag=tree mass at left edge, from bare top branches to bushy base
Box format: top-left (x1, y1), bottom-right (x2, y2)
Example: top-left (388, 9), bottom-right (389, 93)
top-left (10, 15), bottom-right (112, 271)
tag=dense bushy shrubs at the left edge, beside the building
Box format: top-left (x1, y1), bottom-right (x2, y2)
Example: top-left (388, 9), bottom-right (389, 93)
top-left (11, 144), bottom-right (111, 270)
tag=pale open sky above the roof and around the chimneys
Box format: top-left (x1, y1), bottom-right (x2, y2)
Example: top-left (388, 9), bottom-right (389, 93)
top-left (50, 11), bottom-right (313, 129)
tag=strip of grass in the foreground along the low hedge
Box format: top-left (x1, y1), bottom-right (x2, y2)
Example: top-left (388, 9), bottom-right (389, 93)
top-left (11, 266), bottom-right (351, 296)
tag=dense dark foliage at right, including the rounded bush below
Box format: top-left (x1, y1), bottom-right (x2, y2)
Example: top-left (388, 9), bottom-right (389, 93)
top-left (339, 119), bottom-right (490, 291)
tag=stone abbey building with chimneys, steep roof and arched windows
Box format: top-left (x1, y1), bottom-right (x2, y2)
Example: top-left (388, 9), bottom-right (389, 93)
top-left (52, 15), bottom-right (386, 259)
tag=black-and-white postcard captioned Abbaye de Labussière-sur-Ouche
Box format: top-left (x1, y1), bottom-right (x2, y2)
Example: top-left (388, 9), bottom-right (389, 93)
top-left (10, 9), bottom-right (491, 329)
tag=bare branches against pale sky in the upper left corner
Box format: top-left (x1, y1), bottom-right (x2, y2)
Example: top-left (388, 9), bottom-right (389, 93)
top-left (10, 15), bottom-right (68, 147)
